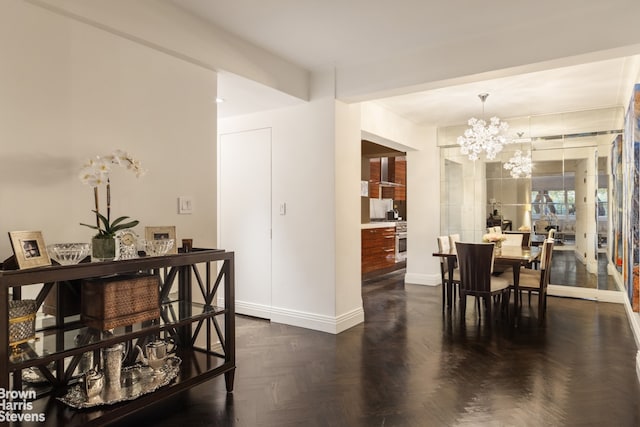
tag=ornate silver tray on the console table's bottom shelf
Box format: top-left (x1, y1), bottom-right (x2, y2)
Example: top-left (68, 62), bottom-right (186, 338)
top-left (58, 356), bottom-right (182, 409)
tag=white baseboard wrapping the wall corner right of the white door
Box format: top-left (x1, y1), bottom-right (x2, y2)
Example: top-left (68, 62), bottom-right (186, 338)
top-left (218, 298), bottom-right (364, 334)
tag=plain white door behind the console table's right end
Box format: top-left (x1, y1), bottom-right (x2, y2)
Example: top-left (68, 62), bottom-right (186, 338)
top-left (219, 129), bottom-right (271, 319)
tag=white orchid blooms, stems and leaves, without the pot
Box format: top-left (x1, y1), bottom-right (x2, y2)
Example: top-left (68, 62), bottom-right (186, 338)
top-left (79, 150), bottom-right (146, 238)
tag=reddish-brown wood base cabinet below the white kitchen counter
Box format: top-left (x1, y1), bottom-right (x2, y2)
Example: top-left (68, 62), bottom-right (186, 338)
top-left (361, 227), bottom-right (396, 274)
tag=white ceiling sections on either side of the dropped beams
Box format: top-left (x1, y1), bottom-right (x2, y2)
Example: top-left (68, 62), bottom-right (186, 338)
top-left (170, 0), bottom-right (640, 127)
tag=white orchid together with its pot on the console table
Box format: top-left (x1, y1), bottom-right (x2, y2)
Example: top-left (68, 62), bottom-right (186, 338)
top-left (79, 150), bottom-right (146, 261)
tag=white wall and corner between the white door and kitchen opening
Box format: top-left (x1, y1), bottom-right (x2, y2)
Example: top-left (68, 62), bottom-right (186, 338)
top-left (219, 76), bottom-right (364, 333)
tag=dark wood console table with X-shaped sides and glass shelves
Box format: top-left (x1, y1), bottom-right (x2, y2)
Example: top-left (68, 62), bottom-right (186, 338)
top-left (0, 249), bottom-right (236, 427)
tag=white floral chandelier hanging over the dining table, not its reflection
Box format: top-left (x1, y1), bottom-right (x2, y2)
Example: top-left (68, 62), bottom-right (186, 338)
top-left (458, 93), bottom-right (509, 160)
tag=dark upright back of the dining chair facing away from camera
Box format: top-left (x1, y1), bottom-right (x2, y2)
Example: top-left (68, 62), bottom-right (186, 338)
top-left (456, 242), bottom-right (495, 292)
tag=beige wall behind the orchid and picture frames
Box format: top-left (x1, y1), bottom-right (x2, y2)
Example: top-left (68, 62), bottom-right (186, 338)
top-left (0, 1), bottom-right (216, 259)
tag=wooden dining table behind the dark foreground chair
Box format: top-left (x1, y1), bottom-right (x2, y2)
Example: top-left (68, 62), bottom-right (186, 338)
top-left (433, 242), bottom-right (541, 323)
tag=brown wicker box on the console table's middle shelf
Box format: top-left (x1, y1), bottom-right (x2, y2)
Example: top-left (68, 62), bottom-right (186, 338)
top-left (80, 275), bottom-right (160, 331)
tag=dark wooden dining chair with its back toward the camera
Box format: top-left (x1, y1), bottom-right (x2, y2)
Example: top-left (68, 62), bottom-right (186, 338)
top-left (456, 242), bottom-right (510, 321)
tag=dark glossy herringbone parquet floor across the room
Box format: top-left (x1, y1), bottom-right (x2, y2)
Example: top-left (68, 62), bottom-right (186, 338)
top-left (119, 271), bottom-right (640, 427)
